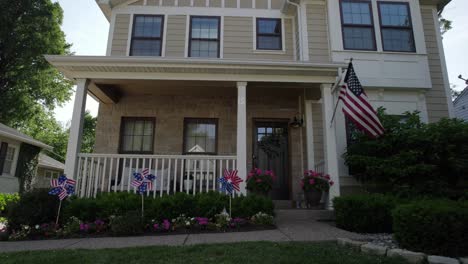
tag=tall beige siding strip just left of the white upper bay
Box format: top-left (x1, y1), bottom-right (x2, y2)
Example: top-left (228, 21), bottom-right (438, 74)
top-left (306, 4), bottom-right (330, 63)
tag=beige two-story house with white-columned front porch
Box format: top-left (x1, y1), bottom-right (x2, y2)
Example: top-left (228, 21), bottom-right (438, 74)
top-left (47, 0), bottom-right (453, 206)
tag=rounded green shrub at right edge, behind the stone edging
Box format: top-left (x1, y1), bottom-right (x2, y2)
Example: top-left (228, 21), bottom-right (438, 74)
top-left (393, 200), bottom-right (468, 256)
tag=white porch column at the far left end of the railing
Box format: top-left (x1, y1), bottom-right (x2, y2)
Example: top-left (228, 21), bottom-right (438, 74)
top-left (65, 79), bottom-right (89, 180)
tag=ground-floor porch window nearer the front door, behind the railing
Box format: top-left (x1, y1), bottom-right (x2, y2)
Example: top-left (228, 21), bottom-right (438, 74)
top-left (184, 118), bottom-right (218, 154)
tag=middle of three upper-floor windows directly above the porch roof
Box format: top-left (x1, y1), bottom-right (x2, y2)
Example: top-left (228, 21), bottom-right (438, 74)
top-left (189, 17), bottom-right (220, 58)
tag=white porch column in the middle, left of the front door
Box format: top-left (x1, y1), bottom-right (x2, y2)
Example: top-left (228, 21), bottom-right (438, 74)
top-left (237, 82), bottom-right (247, 195)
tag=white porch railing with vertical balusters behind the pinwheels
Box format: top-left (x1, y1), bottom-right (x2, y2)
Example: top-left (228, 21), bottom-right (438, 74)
top-left (75, 153), bottom-right (237, 197)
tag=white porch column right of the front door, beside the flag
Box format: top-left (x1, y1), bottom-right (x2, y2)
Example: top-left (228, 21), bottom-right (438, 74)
top-left (320, 84), bottom-right (340, 209)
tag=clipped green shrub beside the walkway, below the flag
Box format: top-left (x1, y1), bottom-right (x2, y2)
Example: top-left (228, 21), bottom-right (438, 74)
top-left (333, 194), bottom-right (398, 233)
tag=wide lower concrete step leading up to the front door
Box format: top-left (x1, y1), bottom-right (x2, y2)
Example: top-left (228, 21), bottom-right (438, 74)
top-left (275, 209), bottom-right (335, 221)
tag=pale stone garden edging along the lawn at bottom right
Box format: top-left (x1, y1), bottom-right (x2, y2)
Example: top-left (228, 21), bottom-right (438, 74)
top-left (337, 238), bottom-right (468, 264)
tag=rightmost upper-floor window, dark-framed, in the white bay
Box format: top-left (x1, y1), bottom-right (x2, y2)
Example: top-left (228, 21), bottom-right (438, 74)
top-left (379, 2), bottom-right (416, 52)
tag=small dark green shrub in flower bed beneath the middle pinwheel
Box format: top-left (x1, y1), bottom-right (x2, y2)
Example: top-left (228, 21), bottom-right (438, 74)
top-left (109, 211), bottom-right (144, 236)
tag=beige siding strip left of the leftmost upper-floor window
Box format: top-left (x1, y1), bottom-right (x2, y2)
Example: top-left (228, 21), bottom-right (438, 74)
top-left (111, 14), bottom-right (130, 56)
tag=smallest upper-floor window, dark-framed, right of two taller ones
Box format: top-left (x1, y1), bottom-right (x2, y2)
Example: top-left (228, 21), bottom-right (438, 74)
top-left (257, 18), bottom-right (282, 50)
